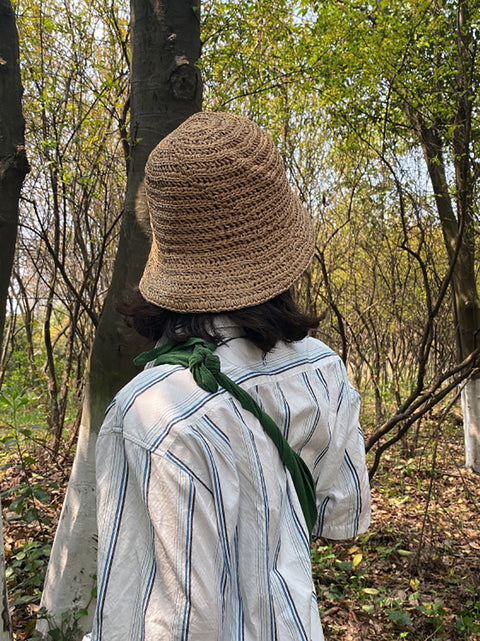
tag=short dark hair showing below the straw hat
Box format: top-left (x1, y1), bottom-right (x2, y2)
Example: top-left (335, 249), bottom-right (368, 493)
top-left (115, 288), bottom-right (319, 353)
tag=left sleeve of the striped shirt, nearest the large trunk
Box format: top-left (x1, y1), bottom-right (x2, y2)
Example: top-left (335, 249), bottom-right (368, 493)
top-left (92, 402), bottom-right (235, 641)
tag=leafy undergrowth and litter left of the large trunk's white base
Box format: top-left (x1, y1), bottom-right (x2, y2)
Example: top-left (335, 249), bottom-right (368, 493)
top-left (0, 388), bottom-right (66, 633)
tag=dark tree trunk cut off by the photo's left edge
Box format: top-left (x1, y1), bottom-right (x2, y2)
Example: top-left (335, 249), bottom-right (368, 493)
top-left (0, 0), bottom-right (28, 641)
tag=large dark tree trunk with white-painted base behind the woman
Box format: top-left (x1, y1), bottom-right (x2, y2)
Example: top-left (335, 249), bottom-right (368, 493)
top-left (37, 0), bottom-right (201, 635)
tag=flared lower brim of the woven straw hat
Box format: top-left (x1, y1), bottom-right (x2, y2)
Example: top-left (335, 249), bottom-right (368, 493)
top-left (139, 193), bottom-right (315, 313)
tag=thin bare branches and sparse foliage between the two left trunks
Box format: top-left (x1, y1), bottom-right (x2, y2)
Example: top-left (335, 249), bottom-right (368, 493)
top-left (0, 0), bottom-right (129, 450)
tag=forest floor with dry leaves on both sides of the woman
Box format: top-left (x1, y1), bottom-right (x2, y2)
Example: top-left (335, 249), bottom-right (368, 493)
top-left (0, 412), bottom-right (480, 641)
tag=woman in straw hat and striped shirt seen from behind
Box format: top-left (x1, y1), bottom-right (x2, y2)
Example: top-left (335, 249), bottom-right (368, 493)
top-left (88, 113), bottom-right (370, 641)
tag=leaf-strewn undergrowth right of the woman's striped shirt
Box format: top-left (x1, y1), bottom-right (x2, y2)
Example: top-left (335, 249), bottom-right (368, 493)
top-left (312, 412), bottom-right (480, 641)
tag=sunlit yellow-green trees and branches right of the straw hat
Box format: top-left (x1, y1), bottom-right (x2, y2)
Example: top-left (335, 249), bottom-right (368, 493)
top-left (202, 0), bottom-right (480, 472)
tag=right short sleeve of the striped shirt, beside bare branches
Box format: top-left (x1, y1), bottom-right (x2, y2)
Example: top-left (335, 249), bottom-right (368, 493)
top-left (313, 359), bottom-right (370, 540)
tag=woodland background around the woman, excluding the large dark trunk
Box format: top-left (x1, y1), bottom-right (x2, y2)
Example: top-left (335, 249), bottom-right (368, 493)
top-left (0, 0), bottom-right (480, 641)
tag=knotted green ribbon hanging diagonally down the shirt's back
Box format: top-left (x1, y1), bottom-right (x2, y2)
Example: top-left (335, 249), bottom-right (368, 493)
top-left (134, 338), bottom-right (317, 534)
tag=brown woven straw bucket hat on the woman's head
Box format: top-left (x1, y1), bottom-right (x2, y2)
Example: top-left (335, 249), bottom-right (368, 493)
top-left (140, 113), bottom-right (314, 312)
